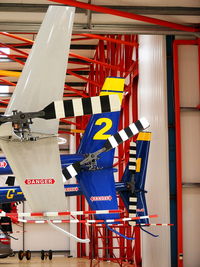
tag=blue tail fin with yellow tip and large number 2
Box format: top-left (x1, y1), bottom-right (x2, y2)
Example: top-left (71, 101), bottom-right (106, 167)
top-left (77, 77), bottom-right (124, 219)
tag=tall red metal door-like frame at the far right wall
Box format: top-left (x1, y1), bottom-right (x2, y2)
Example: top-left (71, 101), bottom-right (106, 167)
top-left (173, 39), bottom-right (200, 267)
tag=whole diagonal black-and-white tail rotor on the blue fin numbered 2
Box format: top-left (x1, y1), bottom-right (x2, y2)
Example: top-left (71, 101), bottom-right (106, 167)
top-left (62, 118), bottom-right (150, 180)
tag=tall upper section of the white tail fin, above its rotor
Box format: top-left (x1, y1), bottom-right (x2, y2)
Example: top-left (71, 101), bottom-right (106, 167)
top-left (5, 6), bottom-right (74, 134)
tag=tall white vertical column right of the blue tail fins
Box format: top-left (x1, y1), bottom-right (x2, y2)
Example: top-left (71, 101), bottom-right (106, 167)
top-left (138, 35), bottom-right (171, 267)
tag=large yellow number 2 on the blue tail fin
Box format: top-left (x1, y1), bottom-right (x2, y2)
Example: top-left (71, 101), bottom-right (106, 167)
top-left (93, 118), bottom-right (112, 140)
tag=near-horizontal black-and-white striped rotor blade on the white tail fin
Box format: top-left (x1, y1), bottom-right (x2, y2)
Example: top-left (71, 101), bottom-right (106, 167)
top-left (43, 94), bottom-right (121, 119)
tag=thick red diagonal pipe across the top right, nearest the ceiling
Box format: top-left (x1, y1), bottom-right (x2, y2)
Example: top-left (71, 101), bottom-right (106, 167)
top-left (49, 0), bottom-right (199, 32)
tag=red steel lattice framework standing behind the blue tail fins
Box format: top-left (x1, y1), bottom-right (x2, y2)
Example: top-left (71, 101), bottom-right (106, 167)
top-left (72, 35), bottom-right (141, 266)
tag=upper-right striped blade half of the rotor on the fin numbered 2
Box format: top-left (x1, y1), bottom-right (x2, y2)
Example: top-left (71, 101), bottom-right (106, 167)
top-left (104, 118), bottom-right (149, 151)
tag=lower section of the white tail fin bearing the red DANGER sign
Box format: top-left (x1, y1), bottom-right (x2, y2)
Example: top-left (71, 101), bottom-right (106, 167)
top-left (0, 137), bottom-right (66, 212)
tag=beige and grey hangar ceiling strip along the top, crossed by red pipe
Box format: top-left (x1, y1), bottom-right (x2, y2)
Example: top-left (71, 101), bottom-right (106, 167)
top-left (0, 0), bottom-right (200, 34)
